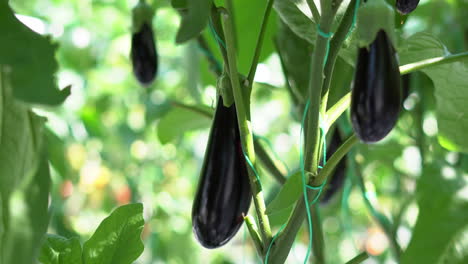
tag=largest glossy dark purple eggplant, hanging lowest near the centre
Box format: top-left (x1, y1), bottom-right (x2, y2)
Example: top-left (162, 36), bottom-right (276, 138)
top-left (192, 97), bottom-right (252, 248)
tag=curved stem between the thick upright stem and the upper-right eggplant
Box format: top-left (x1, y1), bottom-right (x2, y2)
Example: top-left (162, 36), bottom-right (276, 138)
top-left (322, 0), bottom-right (357, 112)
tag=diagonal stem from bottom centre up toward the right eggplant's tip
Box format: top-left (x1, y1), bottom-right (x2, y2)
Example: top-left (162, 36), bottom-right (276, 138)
top-left (269, 135), bottom-right (358, 264)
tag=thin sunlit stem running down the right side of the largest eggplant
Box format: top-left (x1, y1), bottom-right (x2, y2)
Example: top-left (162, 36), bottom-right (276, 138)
top-left (221, 6), bottom-right (271, 248)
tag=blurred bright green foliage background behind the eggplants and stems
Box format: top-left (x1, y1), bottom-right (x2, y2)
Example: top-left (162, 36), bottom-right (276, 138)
top-left (0, 0), bottom-right (468, 263)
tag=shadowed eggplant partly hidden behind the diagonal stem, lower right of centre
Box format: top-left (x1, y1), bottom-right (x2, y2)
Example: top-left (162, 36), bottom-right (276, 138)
top-left (320, 129), bottom-right (346, 205)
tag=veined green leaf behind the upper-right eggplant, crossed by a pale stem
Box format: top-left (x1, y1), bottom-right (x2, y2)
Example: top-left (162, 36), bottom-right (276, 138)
top-left (399, 33), bottom-right (468, 152)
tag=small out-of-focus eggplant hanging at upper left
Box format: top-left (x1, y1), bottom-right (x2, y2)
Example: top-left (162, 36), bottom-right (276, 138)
top-left (130, 23), bottom-right (158, 85)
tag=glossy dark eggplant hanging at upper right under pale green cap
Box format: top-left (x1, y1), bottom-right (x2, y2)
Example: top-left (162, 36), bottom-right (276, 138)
top-left (351, 30), bottom-right (402, 143)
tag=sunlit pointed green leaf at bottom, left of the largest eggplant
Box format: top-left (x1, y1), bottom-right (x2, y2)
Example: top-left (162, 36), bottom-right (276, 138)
top-left (83, 204), bottom-right (145, 264)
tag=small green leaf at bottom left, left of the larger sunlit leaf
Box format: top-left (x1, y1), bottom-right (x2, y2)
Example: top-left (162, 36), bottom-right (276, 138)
top-left (39, 235), bottom-right (83, 264)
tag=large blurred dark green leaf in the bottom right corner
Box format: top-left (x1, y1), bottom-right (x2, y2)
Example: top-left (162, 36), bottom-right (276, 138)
top-left (401, 164), bottom-right (468, 264)
